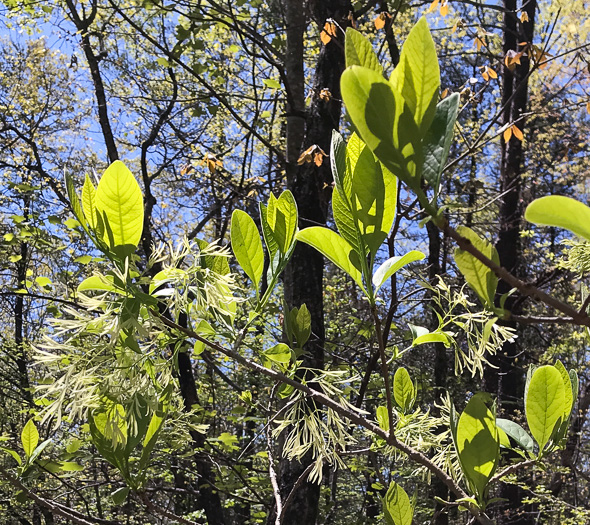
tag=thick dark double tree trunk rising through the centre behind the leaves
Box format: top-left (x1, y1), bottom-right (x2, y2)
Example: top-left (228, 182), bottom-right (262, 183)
top-left (269, 0), bottom-right (352, 525)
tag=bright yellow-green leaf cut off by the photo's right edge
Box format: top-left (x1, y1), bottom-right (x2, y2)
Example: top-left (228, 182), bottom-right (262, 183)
top-left (524, 195), bottom-right (590, 241)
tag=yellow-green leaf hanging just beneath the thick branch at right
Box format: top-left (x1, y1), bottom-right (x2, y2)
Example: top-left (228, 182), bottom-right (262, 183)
top-left (455, 226), bottom-right (500, 309)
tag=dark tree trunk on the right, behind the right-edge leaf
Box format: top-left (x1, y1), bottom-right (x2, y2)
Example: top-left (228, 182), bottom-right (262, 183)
top-left (484, 0), bottom-right (537, 524)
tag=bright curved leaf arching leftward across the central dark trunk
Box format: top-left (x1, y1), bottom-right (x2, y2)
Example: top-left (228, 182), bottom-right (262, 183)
top-left (297, 226), bottom-right (365, 292)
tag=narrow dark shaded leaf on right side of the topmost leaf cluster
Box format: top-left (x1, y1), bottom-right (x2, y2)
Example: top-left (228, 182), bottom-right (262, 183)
top-left (422, 93), bottom-right (459, 197)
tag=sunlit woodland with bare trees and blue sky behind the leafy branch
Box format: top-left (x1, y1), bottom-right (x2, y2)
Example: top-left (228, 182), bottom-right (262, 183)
top-left (0, 0), bottom-right (590, 525)
